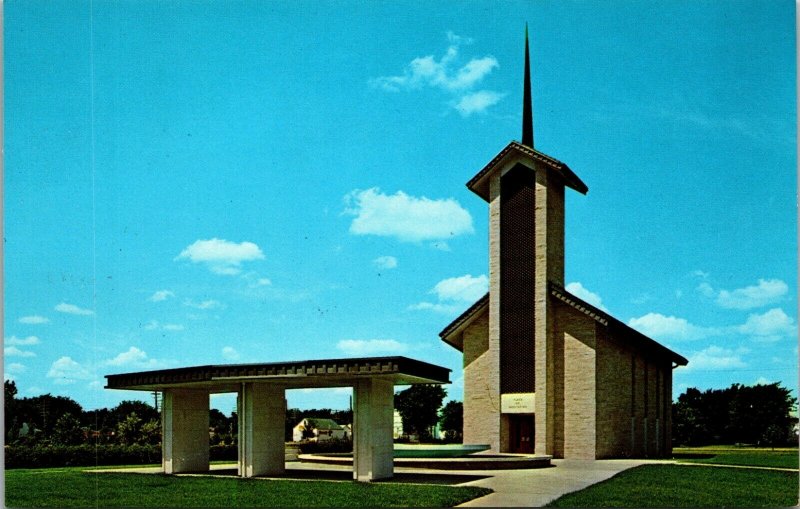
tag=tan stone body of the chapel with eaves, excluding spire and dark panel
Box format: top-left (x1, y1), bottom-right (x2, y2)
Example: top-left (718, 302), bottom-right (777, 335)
top-left (441, 142), bottom-right (687, 459)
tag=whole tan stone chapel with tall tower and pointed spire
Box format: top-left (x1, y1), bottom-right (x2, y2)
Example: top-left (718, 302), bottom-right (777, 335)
top-left (439, 29), bottom-right (688, 459)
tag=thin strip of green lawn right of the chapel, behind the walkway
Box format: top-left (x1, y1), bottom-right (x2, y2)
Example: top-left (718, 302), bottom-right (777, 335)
top-left (672, 445), bottom-right (798, 469)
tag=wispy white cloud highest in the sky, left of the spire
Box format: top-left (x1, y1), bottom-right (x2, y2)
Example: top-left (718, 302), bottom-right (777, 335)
top-left (371, 32), bottom-right (503, 116)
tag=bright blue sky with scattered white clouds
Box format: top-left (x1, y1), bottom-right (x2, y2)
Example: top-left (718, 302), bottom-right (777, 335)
top-left (3, 0), bottom-right (798, 412)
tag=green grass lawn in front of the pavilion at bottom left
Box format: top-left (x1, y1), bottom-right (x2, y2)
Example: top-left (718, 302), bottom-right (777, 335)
top-left (5, 468), bottom-right (491, 507)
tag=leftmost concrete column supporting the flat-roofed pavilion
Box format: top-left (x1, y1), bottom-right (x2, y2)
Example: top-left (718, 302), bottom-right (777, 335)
top-left (161, 389), bottom-right (209, 474)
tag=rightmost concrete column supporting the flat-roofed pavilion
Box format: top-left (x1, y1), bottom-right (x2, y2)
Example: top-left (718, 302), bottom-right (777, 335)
top-left (353, 378), bottom-right (394, 481)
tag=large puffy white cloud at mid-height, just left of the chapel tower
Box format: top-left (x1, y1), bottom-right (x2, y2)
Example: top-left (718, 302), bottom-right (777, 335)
top-left (344, 187), bottom-right (474, 242)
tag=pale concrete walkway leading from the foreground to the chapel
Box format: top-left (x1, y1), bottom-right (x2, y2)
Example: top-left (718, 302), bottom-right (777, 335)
top-left (458, 460), bottom-right (673, 507)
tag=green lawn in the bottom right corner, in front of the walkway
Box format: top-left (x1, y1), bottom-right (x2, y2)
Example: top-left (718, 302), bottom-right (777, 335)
top-left (548, 465), bottom-right (798, 507)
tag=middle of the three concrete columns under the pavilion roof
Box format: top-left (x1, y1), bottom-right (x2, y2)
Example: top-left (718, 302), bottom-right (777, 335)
top-left (238, 383), bottom-right (286, 477)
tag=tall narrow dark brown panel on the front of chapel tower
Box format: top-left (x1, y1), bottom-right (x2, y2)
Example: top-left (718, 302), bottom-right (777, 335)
top-left (500, 165), bottom-right (536, 393)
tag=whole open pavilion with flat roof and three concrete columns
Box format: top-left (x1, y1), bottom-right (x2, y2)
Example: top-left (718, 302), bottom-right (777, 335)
top-left (106, 356), bottom-right (450, 481)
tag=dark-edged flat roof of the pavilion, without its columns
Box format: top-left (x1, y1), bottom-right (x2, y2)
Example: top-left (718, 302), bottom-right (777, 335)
top-left (106, 356), bottom-right (450, 392)
